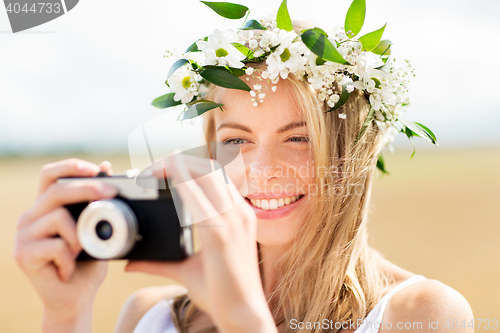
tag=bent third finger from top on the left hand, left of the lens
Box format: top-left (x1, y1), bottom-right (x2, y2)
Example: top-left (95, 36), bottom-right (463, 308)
top-left (19, 207), bottom-right (82, 256)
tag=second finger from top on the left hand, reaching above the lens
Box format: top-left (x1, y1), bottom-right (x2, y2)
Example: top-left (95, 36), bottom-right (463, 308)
top-left (18, 180), bottom-right (118, 229)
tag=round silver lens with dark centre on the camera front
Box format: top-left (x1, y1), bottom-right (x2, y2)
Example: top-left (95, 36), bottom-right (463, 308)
top-left (76, 199), bottom-right (140, 259)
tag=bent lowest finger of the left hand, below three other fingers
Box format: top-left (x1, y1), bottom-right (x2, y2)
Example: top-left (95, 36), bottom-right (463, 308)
top-left (18, 238), bottom-right (76, 281)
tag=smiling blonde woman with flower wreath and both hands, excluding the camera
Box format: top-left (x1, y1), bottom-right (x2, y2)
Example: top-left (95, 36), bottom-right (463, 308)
top-left (11, 0), bottom-right (474, 333)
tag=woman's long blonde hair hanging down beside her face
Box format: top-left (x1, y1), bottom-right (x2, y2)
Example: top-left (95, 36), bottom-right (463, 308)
top-left (168, 56), bottom-right (393, 333)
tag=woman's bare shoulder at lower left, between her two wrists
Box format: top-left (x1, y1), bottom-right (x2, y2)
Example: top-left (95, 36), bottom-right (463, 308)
top-left (115, 285), bottom-right (186, 333)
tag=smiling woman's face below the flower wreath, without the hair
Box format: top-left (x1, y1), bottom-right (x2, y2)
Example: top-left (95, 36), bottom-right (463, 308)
top-left (211, 80), bottom-right (314, 245)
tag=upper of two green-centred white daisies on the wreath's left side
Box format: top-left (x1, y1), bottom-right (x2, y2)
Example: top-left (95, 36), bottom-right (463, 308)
top-left (196, 29), bottom-right (245, 68)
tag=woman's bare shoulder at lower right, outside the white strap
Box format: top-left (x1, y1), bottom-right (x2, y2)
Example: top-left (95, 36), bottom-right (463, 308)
top-left (380, 279), bottom-right (474, 333)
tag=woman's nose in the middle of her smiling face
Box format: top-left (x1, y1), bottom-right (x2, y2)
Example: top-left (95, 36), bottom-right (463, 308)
top-left (249, 146), bottom-right (283, 185)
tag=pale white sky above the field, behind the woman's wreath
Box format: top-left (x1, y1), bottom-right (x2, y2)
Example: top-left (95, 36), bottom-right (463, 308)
top-left (0, 0), bottom-right (500, 155)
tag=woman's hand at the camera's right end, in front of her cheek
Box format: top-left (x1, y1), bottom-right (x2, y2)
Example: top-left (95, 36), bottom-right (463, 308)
top-left (126, 153), bottom-right (277, 332)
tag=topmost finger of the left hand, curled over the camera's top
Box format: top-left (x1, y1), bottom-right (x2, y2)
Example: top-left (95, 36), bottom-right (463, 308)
top-left (38, 158), bottom-right (100, 196)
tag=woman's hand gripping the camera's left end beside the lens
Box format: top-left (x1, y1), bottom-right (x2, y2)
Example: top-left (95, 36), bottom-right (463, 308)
top-left (14, 159), bottom-right (117, 332)
